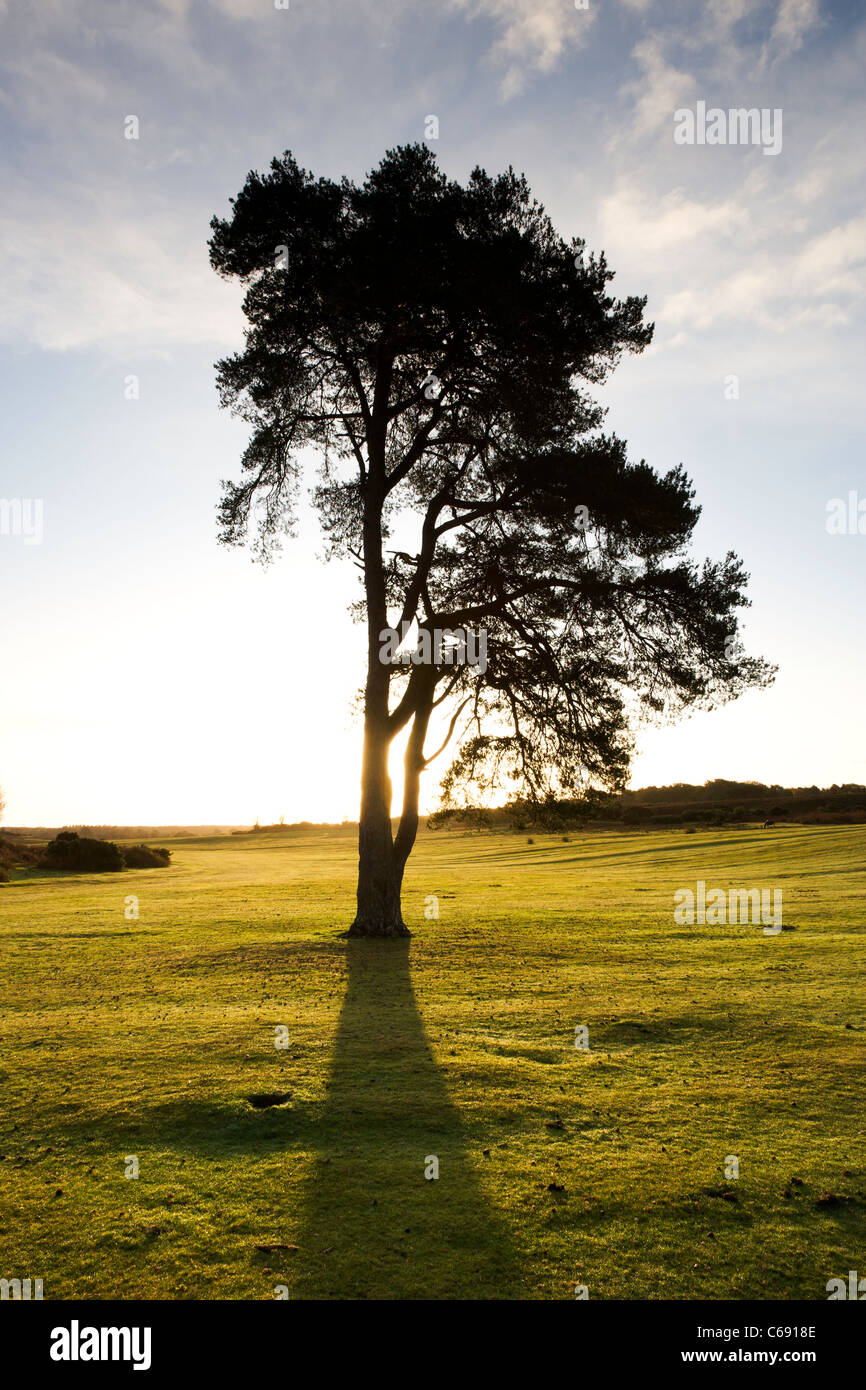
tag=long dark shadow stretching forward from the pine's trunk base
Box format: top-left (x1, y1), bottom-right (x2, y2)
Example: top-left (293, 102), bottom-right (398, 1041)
top-left (286, 941), bottom-right (521, 1298)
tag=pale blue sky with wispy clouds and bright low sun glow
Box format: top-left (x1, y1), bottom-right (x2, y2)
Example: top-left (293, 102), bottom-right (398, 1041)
top-left (0, 0), bottom-right (866, 826)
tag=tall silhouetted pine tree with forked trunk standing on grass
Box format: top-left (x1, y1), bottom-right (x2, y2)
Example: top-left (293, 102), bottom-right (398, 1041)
top-left (210, 145), bottom-right (771, 937)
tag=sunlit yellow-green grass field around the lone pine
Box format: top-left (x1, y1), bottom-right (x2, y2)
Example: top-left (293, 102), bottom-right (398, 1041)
top-left (0, 826), bottom-right (866, 1300)
